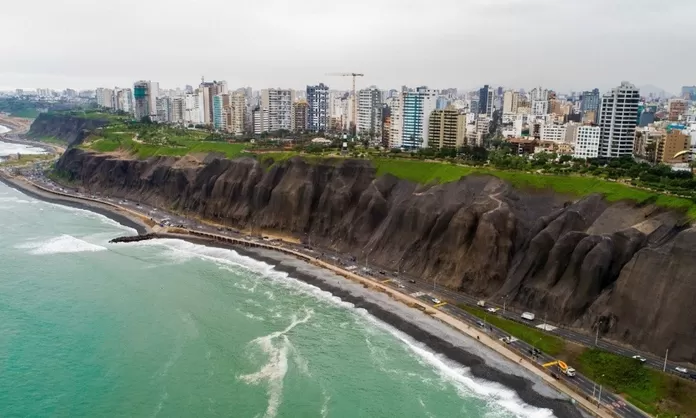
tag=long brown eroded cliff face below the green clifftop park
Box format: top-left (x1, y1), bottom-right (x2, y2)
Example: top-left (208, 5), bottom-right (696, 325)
top-left (57, 149), bottom-right (696, 361)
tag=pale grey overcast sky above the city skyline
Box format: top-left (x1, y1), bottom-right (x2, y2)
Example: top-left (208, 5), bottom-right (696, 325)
top-left (0, 0), bottom-right (696, 93)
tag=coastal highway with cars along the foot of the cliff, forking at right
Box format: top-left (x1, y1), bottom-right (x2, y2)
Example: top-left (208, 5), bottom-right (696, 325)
top-left (10, 167), bottom-right (676, 418)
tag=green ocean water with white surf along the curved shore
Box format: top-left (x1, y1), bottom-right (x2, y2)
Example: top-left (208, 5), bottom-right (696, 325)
top-left (0, 158), bottom-right (551, 418)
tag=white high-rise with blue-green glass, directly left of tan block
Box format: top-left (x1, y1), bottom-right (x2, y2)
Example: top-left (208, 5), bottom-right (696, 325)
top-left (401, 86), bottom-right (437, 149)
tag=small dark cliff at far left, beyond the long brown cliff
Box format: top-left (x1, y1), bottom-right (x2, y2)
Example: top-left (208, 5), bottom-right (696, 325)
top-left (27, 113), bottom-right (109, 146)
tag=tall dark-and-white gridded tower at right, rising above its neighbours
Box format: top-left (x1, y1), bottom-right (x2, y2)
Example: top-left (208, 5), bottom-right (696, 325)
top-left (599, 81), bottom-right (640, 158)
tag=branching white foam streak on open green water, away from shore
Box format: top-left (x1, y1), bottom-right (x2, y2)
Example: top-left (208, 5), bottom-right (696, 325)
top-left (237, 309), bottom-right (313, 418)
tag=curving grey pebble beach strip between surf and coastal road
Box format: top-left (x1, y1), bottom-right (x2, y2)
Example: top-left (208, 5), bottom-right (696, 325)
top-left (0, 168), bottom-right (609, 417)
